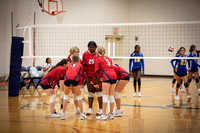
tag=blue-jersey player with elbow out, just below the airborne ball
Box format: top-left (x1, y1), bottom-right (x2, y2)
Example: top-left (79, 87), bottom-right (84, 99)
top-left (171, 47), bottom-right (192, 102)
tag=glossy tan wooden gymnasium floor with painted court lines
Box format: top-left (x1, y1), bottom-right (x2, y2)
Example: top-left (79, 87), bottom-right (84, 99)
top-left (0, 77), bottom-right (200, 133)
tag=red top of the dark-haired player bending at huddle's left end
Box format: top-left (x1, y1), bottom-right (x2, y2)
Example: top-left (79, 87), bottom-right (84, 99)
top-left (41, 66), bottom-right (65, 89)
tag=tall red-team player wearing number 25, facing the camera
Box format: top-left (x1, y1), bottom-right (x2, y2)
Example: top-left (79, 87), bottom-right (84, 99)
top-left (82, 41), bottom-right (103, 115)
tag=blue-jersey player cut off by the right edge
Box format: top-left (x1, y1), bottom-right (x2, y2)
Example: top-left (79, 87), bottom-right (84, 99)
top-left (188, 45), bottom-right (200, 95)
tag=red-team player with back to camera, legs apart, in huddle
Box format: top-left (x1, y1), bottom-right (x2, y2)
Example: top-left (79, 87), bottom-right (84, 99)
top-left (60, 55), bottom-right (87, 120)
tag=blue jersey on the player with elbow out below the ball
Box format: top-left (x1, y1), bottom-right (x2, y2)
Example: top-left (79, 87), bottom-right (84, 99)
top-left (171, 55), bottom-right (190, 74)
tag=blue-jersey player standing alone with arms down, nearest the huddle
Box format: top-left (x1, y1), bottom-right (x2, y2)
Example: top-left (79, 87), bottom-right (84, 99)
top-left (129, 45), bottom-right (144, 97)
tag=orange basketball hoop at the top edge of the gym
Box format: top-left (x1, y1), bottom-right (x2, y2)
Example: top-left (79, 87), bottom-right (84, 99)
top-left (41, 0), bottom-right (66, 16)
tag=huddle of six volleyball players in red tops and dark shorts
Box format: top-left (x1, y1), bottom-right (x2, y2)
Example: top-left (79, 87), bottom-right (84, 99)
top-left (41, 41), bottom-right (130, 120)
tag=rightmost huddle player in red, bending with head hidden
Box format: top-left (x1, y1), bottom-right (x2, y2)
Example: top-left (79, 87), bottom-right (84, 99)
top-left (113, 64), bottom-right (130, 117)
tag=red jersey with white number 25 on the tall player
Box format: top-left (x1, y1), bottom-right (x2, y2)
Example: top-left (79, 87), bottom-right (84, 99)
top-left (82, 51), bottom-right (98, 80)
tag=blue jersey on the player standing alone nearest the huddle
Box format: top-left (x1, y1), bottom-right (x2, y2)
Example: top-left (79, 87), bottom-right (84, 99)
top-left (129, 52), bottom-right (144, 72)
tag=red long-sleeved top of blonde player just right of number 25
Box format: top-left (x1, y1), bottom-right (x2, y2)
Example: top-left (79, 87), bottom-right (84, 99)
top-left (92, 56), bottom-right (117, 83)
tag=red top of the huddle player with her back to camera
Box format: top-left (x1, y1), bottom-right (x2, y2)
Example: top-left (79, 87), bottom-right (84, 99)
top-left (65, 62), bottom-right (84, 85)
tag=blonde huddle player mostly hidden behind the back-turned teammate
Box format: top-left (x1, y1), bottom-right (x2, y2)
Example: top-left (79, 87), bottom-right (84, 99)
top-left (60, 46), bottom-right (80, 114)
